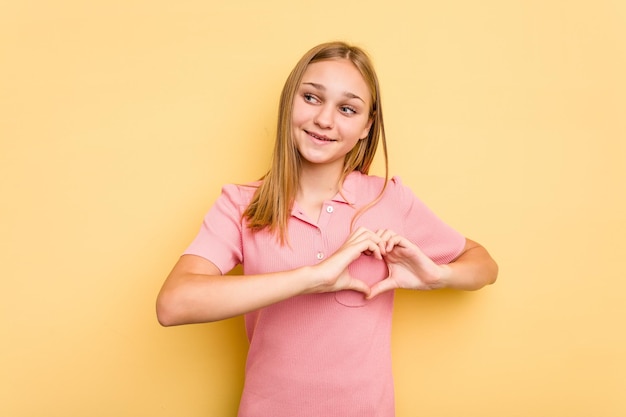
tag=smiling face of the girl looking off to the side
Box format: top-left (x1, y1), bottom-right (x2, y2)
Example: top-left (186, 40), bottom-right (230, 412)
top-left (292, 59), bottom-right (372, 169)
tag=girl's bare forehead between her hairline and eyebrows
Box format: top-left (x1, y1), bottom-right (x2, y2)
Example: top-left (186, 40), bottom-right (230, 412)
top-left (302, 59), bottom-right (371, 100)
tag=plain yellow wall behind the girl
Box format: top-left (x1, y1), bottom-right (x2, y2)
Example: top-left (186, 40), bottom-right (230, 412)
top-left (0, 0), bottom-right (626, 417)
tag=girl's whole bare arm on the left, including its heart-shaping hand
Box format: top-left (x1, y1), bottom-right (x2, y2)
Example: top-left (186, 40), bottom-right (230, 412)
top-left (156, 229), bottom-right (382, 326)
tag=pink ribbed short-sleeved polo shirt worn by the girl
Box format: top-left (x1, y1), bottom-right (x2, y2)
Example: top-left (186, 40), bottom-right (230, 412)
top-left (180, 172), bottom-right (465, 417)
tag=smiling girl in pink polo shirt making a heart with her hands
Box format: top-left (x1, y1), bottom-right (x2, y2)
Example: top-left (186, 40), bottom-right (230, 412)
top-left (157, 42), bottom-right (497, 417)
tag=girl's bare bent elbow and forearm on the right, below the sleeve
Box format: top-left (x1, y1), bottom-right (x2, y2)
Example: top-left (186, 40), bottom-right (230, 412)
top-left (441, 240), bottom-right (498, 291)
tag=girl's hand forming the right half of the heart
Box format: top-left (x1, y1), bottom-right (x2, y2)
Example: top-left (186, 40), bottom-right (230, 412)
top-left (367, 230), bottom-right (447, 299)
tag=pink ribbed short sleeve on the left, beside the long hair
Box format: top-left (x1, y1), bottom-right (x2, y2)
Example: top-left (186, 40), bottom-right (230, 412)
top-left (183, 185), bottom-right (248, 274)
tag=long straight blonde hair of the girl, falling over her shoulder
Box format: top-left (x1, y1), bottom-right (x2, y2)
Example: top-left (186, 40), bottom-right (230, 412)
top-left (243, 42), bottom-right (389, 244)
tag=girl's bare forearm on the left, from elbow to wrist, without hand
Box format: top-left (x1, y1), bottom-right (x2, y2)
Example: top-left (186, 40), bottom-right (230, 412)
top-left (157, 267), bottom-right (315, 326)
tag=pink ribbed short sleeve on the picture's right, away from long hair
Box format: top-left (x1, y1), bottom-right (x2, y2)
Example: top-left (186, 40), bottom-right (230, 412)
top-left (390, 177), bottom-right (465, 264)
